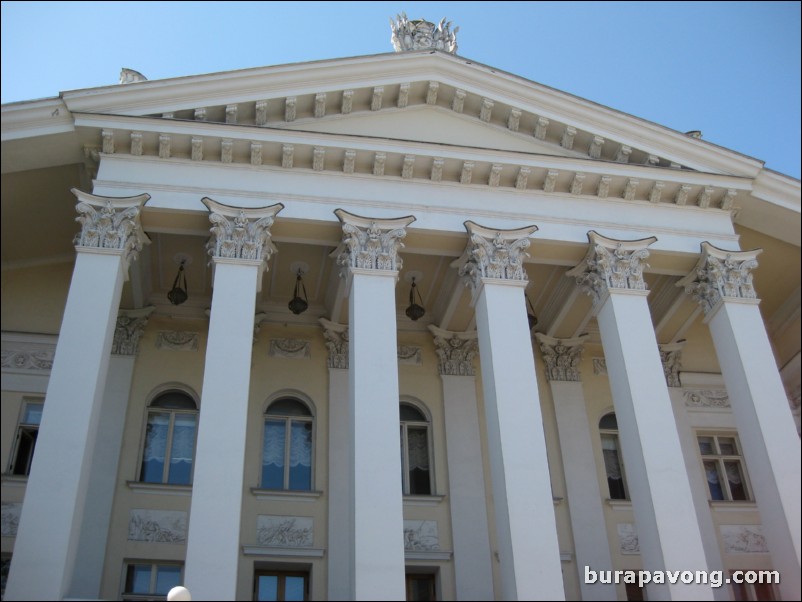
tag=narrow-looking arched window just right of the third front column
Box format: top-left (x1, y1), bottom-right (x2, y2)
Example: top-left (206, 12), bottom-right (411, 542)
top-left (400, 402), bottom-right (432, 495)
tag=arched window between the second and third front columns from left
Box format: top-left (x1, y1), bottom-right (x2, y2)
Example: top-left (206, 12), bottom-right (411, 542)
top-left (262, 398), bottom-right (314, 491)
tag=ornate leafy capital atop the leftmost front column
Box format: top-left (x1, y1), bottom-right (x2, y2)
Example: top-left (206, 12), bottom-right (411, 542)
top-left (72, 188), bottom-right (150, 279)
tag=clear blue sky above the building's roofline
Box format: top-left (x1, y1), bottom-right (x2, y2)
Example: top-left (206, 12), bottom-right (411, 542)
top-left (0, 1), bottom-right (802, 178)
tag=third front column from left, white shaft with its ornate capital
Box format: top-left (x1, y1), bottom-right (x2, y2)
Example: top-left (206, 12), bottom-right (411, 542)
top-left (334, 209), bottom-right (415, 600)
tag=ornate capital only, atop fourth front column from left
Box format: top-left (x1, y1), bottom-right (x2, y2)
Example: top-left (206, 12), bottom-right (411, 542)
top-left (451, 221), bottom-right (537, 292)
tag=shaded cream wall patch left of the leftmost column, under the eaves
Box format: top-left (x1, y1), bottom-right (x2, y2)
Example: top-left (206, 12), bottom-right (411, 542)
top-left (0, 261), bottom-right (73, 334)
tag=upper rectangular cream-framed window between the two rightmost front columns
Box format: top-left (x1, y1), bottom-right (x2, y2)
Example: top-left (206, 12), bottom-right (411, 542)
top-left (697, 435), bottom-right (751, 502)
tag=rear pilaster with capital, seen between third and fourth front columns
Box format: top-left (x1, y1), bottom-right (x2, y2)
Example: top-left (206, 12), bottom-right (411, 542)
top-left (429, 325), bottom-right (495, 600)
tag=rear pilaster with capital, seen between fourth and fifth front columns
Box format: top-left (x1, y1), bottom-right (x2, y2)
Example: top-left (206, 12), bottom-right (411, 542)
top-left (535, 333), bottom-right (617, 600)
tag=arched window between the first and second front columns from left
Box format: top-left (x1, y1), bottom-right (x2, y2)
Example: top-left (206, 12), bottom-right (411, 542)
top-left (139, 389), bottom-right (198, 485)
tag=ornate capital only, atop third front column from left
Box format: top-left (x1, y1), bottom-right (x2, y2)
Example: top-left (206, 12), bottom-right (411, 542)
top-left (332, 209), bottom-right (415, 275)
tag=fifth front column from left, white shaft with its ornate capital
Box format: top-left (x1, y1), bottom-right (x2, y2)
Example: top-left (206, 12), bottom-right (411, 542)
top-left (568, 232), bottom-right (713, 600)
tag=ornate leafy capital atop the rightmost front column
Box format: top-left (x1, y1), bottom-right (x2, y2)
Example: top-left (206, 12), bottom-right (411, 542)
top-left (677, 242), bottom-right (763, 316)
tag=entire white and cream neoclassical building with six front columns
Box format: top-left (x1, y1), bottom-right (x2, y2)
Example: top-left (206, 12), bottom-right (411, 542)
top-left (0, 16), bottom-right (800, 600)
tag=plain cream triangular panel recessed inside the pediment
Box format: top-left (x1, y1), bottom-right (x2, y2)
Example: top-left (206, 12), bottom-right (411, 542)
top-left (280, 105), bottom-right (583, 158)
